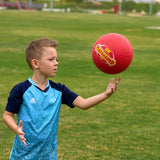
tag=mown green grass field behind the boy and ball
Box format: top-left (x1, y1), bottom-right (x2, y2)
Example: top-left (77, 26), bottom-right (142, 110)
top-left (0, 11), bottom-right (160, 160)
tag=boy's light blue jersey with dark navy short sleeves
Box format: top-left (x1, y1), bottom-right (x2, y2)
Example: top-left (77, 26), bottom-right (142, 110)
top-left (6, 78), bottom-right (78, 160)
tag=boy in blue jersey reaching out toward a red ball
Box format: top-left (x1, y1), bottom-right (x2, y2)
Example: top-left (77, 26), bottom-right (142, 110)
top-left (3, 38), bottom-right (121, 160)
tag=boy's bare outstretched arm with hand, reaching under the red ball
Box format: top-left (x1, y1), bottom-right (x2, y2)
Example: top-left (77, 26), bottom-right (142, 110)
top-left (73, 78), bottom-right (121, 109)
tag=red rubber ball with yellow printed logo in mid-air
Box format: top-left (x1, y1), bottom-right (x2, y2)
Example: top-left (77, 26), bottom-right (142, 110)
top-left (92, 33), bottom-right (133, 74)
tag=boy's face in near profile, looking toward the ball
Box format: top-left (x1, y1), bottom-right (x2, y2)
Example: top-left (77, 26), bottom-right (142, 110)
top-left (38, 47), bottom-right (58, 77)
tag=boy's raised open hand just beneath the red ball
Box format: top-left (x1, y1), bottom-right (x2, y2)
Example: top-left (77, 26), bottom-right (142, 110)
top-left (106, 77), bottom-right (121, 97)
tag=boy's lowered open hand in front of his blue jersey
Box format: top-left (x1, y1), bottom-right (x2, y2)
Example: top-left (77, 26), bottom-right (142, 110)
top-left (16, 120), bottom-right (27, 146)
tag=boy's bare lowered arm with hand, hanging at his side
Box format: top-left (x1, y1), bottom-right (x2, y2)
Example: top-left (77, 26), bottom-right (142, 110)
top-left (3, 111), bottom-right (27, 146)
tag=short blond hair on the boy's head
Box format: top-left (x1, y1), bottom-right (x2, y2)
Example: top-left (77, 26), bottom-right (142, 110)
top-left (26, 38), bottom-right (58, 69)
